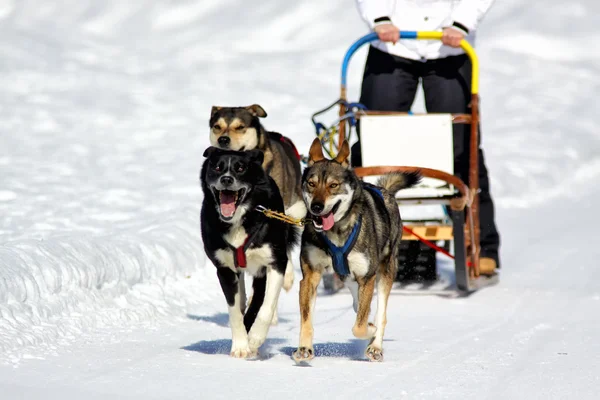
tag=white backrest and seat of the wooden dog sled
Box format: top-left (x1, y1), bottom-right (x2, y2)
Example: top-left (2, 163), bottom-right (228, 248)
top-left (359, 114), bottom-right (455, 203)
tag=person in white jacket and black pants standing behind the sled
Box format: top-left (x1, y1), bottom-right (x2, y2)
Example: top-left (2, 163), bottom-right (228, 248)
top-left (351, 0), bottom-right (500, 275)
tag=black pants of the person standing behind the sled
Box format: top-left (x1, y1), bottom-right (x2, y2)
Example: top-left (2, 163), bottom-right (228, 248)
top-left (351, 47), bottom-right (500, 266)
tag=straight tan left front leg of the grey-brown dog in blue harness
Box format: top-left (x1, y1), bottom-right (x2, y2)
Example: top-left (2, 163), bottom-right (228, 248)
top-left (292, 256), bottom-right (322, 362)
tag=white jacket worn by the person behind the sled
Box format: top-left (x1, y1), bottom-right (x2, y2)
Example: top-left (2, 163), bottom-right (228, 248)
top-left (356, 0), bottom-right (494, 60)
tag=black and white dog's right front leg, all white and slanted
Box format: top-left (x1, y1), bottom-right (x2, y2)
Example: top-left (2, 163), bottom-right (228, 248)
top-left (248, 267), bottom-right (283, 351)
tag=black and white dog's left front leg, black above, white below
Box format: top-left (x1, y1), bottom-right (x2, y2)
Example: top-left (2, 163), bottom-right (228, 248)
top-left (217, 267), bottom-right (252, 358)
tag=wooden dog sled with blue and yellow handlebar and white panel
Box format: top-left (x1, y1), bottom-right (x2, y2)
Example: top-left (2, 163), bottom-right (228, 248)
top-left (312, 31), bottom-right (498, 295)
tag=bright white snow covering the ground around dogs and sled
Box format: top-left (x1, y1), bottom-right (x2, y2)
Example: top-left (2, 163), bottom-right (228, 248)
top-left (0, 0), bottom-right (600, 399)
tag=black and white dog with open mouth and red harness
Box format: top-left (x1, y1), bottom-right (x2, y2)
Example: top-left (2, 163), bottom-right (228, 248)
top-left (200, 147), bottom-right (298, 358)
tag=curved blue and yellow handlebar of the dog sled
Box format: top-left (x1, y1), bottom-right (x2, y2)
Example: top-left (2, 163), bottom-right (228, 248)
top-left (342, 31), bottom-right (479, 98)
